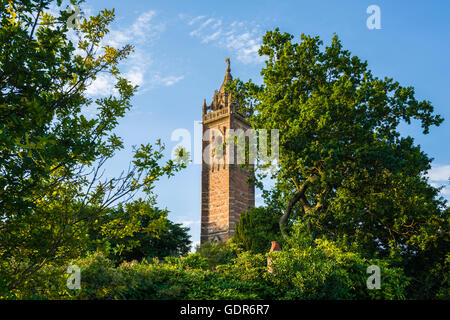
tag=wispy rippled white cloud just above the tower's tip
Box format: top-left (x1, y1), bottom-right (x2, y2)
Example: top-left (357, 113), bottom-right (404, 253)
top-left (180, 15), bottom-right (264, 64)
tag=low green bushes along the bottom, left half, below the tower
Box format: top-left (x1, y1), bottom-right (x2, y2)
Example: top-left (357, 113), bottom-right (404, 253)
top-left (46, 253), bottom-right (268, 300)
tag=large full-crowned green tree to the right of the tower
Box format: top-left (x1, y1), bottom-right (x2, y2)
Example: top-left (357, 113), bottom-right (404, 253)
top-left (229, 29), bottom-right (449, 296)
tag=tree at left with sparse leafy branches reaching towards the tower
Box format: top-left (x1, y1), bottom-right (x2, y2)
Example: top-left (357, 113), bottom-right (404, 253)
top-left (0, 0), bottom-right (184, 293)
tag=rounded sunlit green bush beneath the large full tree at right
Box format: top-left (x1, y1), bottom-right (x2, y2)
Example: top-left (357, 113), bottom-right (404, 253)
top-left (268, 224), bottom-right (409, 299)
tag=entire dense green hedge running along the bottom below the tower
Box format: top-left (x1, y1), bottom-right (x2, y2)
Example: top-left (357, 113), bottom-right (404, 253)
top-left (7, 235), bottom-right (408, 300)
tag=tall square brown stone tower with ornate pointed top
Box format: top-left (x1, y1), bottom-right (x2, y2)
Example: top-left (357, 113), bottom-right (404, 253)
top-left (200, 59), bottom-right (255, 243)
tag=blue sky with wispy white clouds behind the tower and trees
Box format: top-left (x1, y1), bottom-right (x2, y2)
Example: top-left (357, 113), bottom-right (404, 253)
top-left (74, 0), bottom-right (450, 248)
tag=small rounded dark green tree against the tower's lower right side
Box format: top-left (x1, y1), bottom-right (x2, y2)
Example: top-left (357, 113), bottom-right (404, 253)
top-left (233, 207), bottom-right (281, 253)
